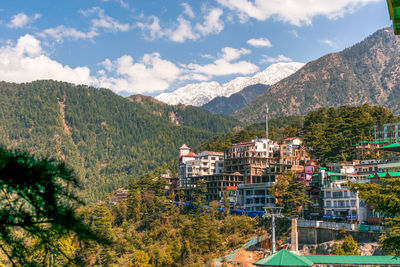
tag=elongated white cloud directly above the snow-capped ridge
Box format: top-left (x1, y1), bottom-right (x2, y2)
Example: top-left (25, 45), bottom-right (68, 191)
top-left (185, 47), bottom-right (258, 80)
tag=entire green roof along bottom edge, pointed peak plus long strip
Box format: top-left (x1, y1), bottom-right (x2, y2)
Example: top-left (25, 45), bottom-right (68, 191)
top-left (253, 249), bottom-right (400, 266)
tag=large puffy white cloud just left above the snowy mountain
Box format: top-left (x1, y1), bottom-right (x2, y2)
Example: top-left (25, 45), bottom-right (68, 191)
top-left (99, 53), bottom-right (181, 93)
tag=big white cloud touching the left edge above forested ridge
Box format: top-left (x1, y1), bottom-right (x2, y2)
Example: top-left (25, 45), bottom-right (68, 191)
top-left (0, 34), bottom-right (96, 84)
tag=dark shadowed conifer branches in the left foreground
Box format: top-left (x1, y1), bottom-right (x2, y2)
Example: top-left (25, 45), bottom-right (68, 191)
top-left (0, 148), bottom-right (109, 266)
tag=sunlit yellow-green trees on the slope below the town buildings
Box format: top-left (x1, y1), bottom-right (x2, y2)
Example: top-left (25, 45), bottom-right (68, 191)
top-left (78, 169), bottom-right (257, 266)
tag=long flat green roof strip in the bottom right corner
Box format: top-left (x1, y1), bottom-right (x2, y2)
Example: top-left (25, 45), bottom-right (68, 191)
top-left (301, 255), bottom-right (400, 265)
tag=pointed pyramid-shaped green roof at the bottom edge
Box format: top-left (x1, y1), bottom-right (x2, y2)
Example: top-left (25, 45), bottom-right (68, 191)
top-left (253, 249), bottom-right (313, 266)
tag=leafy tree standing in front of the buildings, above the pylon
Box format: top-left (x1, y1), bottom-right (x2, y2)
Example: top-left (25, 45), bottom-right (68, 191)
top-left (271, 171), bottom-right (311, 218)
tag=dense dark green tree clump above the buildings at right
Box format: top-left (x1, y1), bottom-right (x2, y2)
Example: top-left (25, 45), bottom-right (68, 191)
top-left (303, 104), bottom-right (396, 162)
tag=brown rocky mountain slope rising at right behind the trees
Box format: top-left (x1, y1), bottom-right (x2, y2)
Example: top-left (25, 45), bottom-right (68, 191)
top-left (233, 29), bottom-right (400, 122)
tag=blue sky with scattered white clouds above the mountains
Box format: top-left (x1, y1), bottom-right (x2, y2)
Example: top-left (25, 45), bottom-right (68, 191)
top-left (0, 0), bottom-right (391, 96)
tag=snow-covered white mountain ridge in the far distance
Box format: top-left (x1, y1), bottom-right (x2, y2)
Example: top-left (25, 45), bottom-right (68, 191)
top-left (156, 62), bottom-right (304, 107)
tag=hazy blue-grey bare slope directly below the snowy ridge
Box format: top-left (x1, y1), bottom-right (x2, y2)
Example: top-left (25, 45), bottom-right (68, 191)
top-left (201, 84), bottom-right (270, 115)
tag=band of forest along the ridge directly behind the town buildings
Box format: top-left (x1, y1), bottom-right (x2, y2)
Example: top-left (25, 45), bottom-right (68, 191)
top-left (196, 104), bottom-right (397, 163)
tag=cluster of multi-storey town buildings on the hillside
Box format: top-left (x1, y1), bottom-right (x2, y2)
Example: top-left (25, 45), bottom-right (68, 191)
top-left (169, 123), bottom-right (400, 225)
